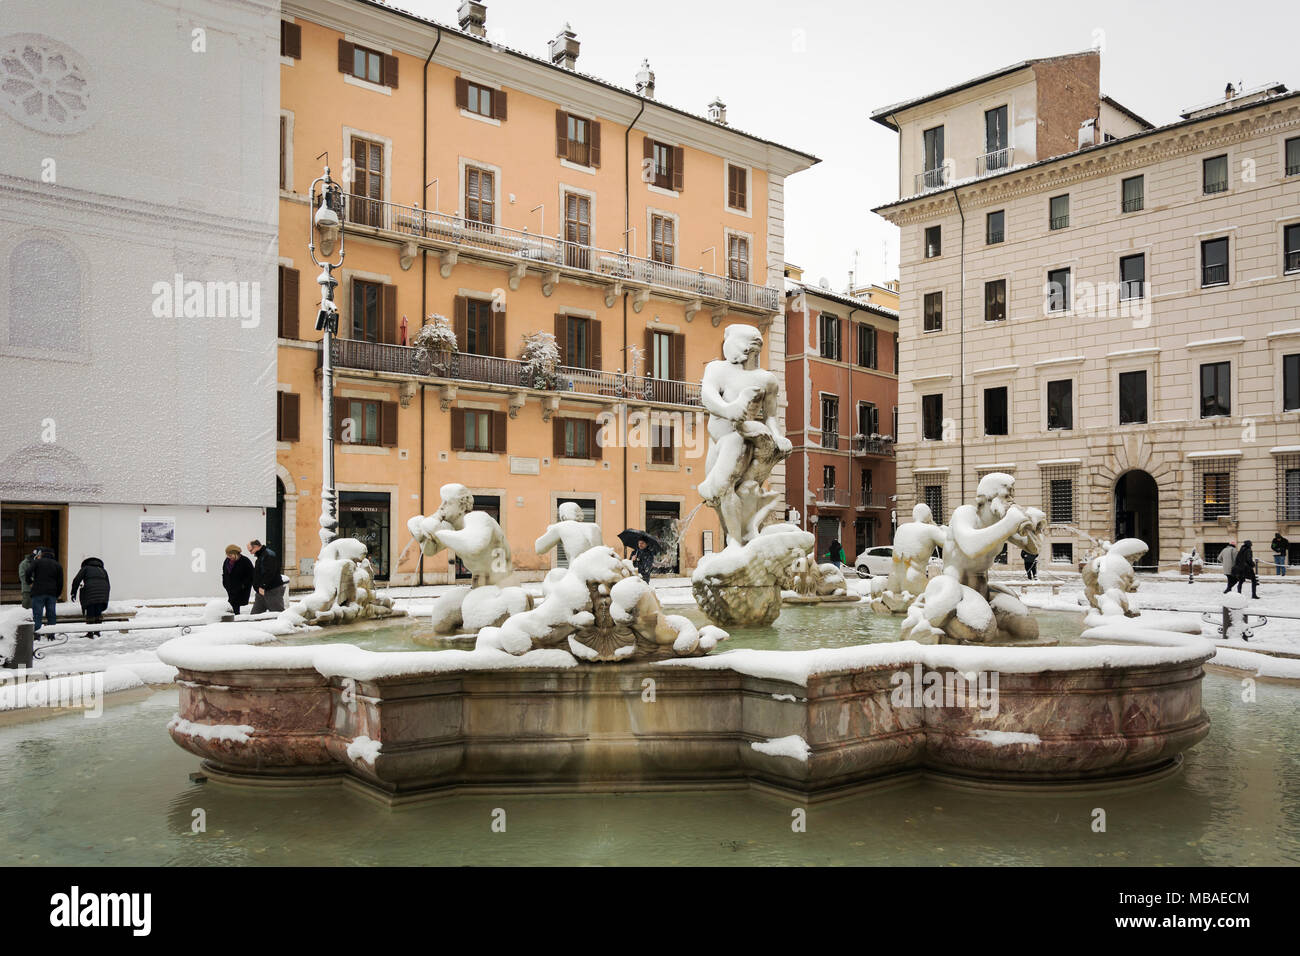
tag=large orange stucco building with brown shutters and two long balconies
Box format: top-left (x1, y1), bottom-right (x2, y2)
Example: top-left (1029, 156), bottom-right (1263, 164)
top-left (268, 0), bottom-right (816, 584)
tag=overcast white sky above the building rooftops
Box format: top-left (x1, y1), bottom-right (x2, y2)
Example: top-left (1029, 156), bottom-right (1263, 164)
top-left (394, 0), bottom-right (1300, 289)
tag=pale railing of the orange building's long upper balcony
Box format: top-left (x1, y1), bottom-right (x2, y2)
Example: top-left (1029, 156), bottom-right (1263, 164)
top-left (347, 196), bottom-right (781, 312)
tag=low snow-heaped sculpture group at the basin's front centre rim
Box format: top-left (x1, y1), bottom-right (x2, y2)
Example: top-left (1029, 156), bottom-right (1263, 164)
top-left (476, 545), bottom-right (727, 662)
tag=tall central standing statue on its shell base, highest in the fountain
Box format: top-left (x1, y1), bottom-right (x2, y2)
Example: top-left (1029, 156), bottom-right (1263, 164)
top-left (692, 324), bottom-right (814, 626)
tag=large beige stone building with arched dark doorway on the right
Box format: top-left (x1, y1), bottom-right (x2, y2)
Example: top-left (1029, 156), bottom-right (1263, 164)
top-left (872, 53), bottom-right (1300, 568)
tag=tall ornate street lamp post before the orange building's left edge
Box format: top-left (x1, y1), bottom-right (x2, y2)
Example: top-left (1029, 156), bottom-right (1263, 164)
top-left (307, 165), bottom-right (343, 548)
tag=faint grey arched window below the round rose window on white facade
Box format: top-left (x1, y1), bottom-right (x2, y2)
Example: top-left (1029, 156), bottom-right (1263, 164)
top-left (9, 239), bottom-right (82, 351)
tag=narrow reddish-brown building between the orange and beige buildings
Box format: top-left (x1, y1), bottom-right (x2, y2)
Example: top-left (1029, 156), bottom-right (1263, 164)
top-left (785, 267), bottom-right (898, 563)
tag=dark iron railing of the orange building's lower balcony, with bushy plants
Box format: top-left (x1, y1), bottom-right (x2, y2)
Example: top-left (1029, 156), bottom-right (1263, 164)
top-left (332, 338), bottom-right (699, 407)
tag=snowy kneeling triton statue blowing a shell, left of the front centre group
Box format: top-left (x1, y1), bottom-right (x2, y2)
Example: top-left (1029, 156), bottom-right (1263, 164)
top-left (407, 483), bottom-right (532, 633)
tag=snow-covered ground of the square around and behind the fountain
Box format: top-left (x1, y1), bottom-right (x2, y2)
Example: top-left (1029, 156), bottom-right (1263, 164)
top-left (0, 568), bottom-right (1300, 709)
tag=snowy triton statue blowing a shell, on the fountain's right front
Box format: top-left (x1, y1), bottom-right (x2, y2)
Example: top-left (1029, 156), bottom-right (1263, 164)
top-left (900, 472), bottom-right (1048, 644)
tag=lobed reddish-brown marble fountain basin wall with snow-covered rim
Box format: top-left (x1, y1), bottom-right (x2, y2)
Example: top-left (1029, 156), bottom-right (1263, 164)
top-left (160, 626), bottom-right (1213, 804)
